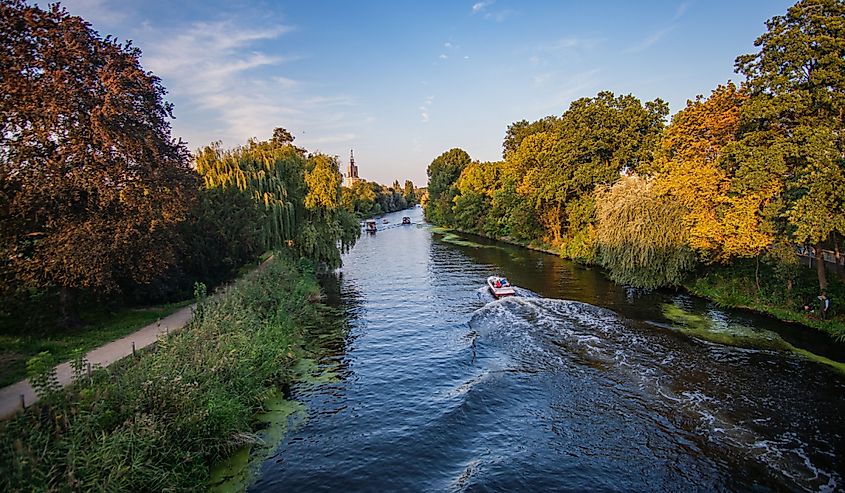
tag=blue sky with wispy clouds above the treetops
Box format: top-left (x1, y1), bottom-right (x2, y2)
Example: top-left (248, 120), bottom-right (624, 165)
top-left (62, 0), bottom-right (794, 185)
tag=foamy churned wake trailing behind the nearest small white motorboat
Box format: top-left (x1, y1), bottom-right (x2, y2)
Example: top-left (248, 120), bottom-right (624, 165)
top-left (469, 296), bottom-right (845, 491)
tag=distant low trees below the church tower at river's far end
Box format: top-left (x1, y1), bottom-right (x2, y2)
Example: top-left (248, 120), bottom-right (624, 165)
top-left (342, 176), bottom-right (420, 219)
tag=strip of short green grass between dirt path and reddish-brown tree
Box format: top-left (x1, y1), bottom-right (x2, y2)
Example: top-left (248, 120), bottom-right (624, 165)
top-left (0, 300), bottom-right (193, 387)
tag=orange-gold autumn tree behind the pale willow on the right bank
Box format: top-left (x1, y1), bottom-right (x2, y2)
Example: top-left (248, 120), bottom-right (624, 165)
top-left (655, 82), bottom-right (782, 262)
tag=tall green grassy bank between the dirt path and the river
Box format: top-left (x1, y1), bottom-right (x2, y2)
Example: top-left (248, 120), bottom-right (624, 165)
top-left (0, 252), bottom-right (332, 491)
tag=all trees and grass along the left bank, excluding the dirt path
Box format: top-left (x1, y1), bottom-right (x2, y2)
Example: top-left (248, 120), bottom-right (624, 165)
top-left (0, 0), bottom-right (416, 491)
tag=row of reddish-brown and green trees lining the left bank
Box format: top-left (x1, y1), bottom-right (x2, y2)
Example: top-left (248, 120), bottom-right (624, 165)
top-left (0, 0), bottom-right (360, 326)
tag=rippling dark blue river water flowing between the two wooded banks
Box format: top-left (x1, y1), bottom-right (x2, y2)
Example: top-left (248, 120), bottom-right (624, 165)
top-left (250, 209), bottom-right (845, 492)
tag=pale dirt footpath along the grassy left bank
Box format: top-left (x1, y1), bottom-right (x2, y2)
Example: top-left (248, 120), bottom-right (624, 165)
top-left (0, 305), bottom-right (194, 419)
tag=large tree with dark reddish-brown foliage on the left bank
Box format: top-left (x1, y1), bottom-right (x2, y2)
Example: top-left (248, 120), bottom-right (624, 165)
top-left (0, 0), bottom-right (196, 324)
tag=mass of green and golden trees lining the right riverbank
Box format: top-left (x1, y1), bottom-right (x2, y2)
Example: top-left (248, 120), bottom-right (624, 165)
top-left (424, 0), bottom-right (845, 339)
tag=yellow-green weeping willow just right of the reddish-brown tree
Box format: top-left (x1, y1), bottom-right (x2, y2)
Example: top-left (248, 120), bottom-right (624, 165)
top-left (196, 141), bottom-right (307, 250)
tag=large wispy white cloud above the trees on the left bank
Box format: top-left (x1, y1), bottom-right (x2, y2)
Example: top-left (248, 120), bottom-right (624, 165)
top-left (132, 17), bottom-right (356, 147)
